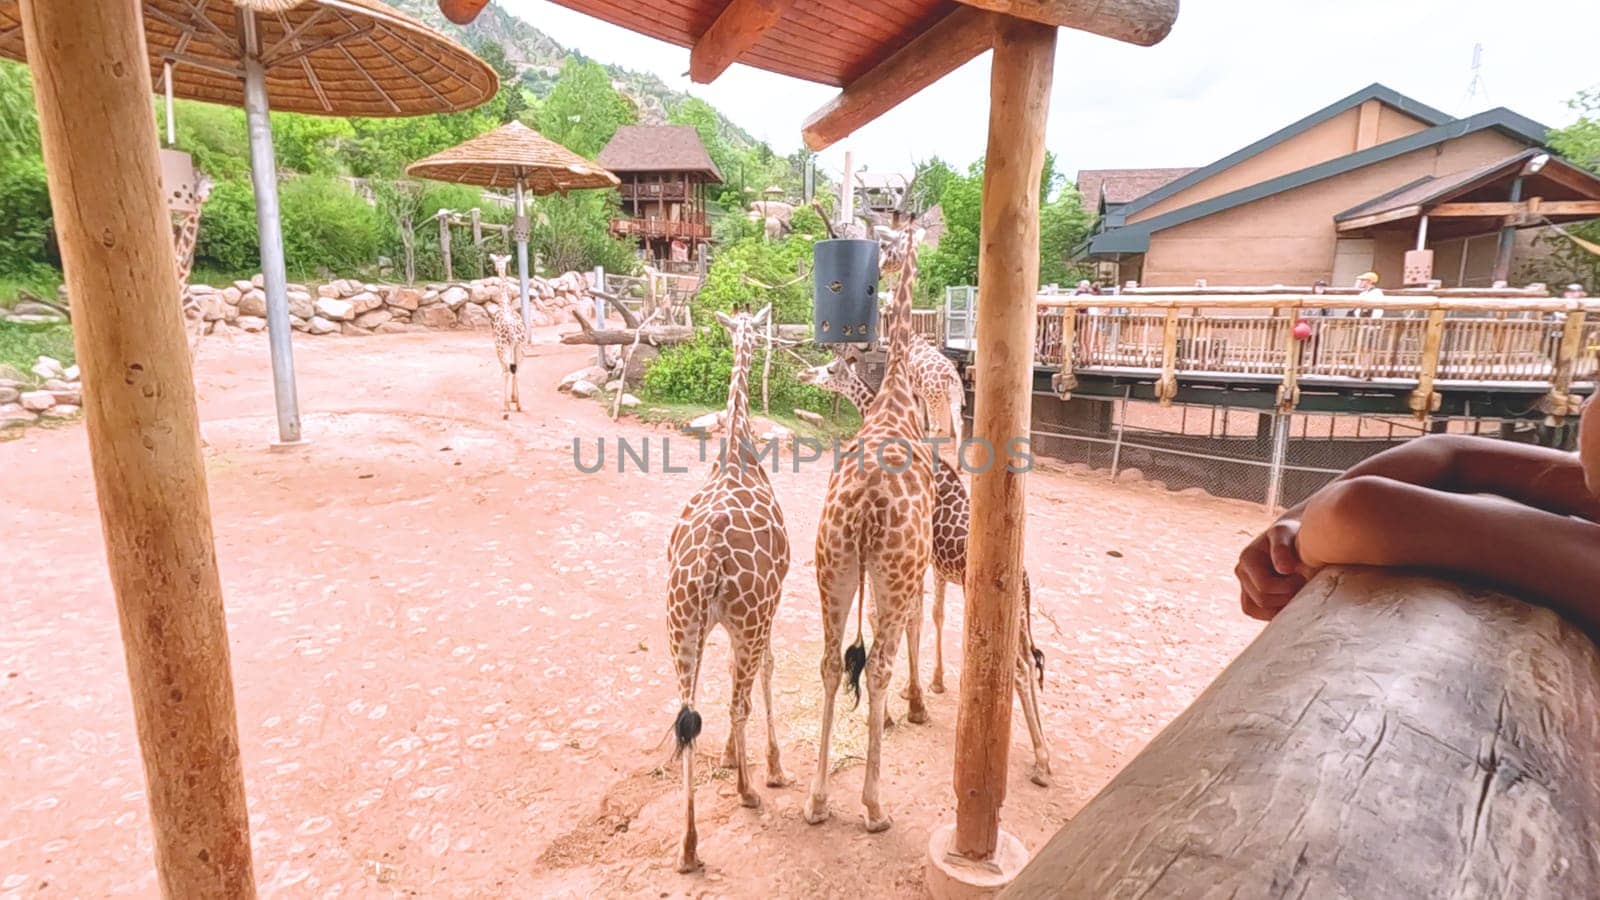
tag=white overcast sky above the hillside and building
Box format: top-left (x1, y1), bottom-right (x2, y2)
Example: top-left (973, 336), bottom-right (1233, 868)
top-left (498, 0), bottom-right (1600, 185)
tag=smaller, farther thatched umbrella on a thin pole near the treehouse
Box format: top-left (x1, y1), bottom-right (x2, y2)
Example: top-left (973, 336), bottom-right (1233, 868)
top-left (405, 122), bottom-right (619, 325)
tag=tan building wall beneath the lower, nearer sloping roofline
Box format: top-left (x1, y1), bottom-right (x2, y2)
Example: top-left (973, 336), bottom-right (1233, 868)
top-left (1139, 130), bottom-right (1525, 287)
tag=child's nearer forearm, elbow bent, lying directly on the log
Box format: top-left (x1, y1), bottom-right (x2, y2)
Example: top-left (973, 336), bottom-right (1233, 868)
top-left (1298, 477), bottom-right (1600, 633)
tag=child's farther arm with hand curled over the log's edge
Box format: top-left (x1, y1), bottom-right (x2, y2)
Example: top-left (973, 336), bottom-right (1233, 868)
top-left (1234, 436), bottom-right (1600, 618)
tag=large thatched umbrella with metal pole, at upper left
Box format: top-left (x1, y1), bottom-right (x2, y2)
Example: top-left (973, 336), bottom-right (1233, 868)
top-left (0, 0), bottom-right (499, 444)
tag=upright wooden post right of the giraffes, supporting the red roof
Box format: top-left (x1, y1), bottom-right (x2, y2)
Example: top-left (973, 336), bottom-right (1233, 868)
top-left (930, 12), bottom-right (1056, 870)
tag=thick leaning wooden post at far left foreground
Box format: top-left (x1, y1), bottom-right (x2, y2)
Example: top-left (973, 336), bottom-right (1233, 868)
top-left (21, 0), bottom-right (256, 898)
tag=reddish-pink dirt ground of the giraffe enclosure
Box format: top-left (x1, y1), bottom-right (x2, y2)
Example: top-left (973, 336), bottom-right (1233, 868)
top-left (0, 325), bottom-right (1266, 897)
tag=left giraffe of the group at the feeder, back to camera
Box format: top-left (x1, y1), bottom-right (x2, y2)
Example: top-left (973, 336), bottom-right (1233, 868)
top-left (667, 307), bottom-right (790, 873)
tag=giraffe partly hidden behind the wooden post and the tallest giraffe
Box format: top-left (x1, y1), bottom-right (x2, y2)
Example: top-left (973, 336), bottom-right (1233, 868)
top-left (800, 357), bottom-right (1051, 786)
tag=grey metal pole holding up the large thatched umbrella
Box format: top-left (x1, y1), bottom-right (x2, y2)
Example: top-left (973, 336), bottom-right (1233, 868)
top-left (238, 10), bottom-right (301, 444)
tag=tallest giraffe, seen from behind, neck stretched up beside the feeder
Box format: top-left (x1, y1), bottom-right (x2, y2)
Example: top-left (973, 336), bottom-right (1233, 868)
top-left (805, 232), bottom-right (933, 833)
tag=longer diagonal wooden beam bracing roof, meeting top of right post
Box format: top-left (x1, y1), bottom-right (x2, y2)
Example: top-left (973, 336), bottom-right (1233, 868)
top-left (800, 6), bottom-right (998, 151)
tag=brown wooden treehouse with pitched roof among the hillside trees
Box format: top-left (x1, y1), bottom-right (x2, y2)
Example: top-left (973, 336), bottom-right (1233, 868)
top-left (598, 125), bottom-right (722, 271)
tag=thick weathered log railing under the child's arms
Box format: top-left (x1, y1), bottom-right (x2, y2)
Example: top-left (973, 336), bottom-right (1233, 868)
top-left (1005, 570), bottom-right (1600, 900)
